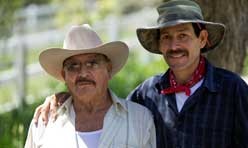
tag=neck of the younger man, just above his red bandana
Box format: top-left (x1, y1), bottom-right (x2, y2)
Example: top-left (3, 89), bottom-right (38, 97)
top-left (172, 58), bottom-right (200, 84)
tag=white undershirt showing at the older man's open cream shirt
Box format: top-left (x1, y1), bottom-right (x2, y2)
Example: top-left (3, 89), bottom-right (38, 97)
top-left (76, 129), bottom-right (102, 148)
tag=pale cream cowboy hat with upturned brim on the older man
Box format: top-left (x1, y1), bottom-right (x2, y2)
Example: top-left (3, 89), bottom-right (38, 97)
top-left (39, 24), bottom-right (129, 81)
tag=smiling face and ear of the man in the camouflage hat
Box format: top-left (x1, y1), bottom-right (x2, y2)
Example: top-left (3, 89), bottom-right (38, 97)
top-left (159, 23), bottom-right (208, 71)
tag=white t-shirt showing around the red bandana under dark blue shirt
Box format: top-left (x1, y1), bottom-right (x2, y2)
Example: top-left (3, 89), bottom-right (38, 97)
top-left (176, 79), bottom-right (204, 112)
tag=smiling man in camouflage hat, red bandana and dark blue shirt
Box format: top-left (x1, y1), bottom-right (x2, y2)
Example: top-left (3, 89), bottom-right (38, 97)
top-left (33, 0), bottom-right (248, 148)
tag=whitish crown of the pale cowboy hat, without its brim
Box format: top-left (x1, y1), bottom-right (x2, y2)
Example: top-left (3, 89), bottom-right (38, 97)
top-left (63, 24), bottom-right (102, 50)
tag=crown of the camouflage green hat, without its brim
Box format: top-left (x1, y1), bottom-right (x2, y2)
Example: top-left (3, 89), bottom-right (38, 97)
top-left (157, 0), bottom-right (203, 24)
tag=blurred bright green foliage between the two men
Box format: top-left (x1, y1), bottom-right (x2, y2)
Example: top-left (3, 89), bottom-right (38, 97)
top-left (110, 53), bottom-right (167, 98)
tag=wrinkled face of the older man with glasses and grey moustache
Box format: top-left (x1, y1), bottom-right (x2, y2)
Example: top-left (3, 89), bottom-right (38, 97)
top-left (62, 53), bottom-right (111, 97)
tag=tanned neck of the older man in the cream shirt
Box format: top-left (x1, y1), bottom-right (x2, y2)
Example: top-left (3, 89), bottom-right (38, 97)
top-left (73, 92), bottom-right (112, 114)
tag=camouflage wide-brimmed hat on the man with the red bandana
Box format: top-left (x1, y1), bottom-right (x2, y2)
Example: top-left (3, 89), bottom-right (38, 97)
top-left (136, 0), bottom-right (225, 54)
